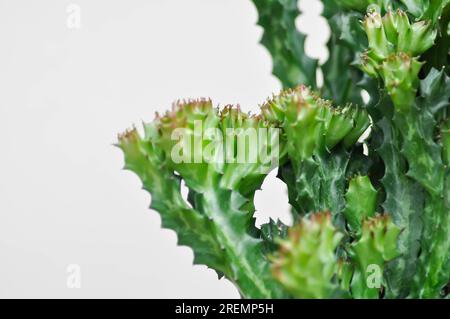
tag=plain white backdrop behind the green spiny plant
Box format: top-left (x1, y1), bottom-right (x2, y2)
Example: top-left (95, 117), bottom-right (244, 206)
top-left (0, 0), bottom-right (329, 298)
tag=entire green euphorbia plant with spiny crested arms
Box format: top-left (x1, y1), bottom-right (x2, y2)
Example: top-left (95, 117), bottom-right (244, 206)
top-left (117, 0), bottom-right (450, 298)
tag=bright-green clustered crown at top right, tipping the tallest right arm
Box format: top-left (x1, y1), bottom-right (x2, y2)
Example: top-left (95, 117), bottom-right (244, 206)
top-left (361, 9), bottom-right (437, 110)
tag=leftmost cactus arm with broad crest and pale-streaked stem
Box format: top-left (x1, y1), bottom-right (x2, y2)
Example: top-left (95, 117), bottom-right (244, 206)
top-left (118, 100), bottom-right (282, 298)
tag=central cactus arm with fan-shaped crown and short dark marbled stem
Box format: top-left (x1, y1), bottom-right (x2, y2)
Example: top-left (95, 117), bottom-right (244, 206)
top-left (261, 86), bottom-right (370, 217)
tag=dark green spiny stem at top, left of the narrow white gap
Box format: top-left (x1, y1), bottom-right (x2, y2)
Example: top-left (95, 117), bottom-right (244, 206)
top-left (252, 0), bottom-right (317, 88)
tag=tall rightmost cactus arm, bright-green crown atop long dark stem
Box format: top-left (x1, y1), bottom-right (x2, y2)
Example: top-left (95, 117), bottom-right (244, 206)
top-left (356, 10), bottom-right (450, 298)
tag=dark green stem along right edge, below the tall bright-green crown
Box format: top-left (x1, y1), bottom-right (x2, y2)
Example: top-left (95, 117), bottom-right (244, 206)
top-left (394, 112), bottom-right (450, 298)
